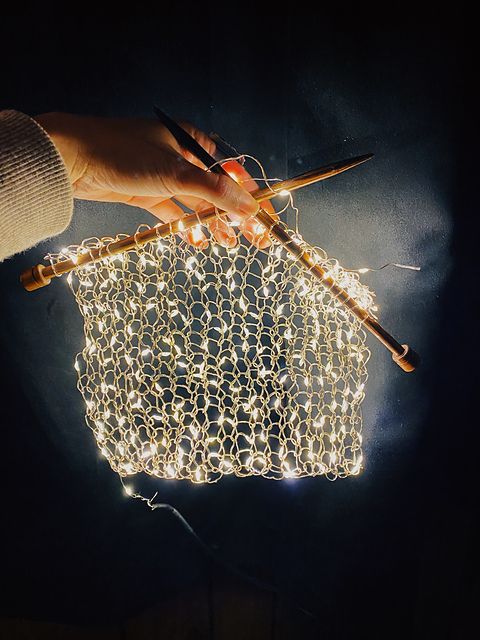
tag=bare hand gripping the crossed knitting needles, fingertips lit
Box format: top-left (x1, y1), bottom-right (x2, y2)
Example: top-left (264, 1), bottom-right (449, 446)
top-left (36, 113), bottom-right (273, 249)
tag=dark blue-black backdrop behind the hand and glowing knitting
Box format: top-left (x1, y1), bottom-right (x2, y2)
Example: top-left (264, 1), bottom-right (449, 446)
top-left (0, 11), bottom-right (478, 639)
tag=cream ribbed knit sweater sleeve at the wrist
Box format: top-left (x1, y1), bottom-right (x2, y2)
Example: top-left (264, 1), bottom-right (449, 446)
top-left (0, 111), bottom-right (73, 261)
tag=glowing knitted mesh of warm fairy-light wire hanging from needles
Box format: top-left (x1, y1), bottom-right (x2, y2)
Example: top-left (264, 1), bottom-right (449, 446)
top-left (47, 226), bottom-right (374, 482)
